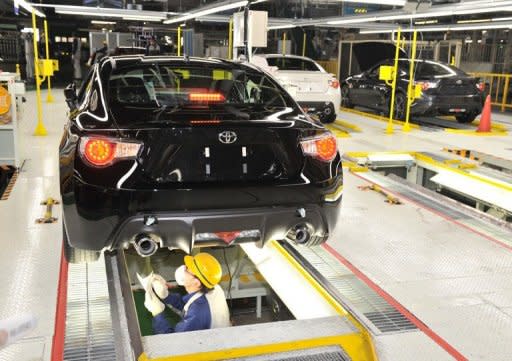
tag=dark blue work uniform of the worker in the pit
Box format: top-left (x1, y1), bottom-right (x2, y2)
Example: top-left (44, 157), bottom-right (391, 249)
top-left (152, 292), bottom-right (212, 334)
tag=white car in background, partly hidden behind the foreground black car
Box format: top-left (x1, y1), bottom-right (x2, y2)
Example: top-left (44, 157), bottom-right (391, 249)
top-left (251, 54), bottom-right (341, 123)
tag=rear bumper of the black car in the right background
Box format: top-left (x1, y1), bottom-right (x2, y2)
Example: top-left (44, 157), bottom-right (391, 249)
top-left (411, 94), bottom-right (483, 115)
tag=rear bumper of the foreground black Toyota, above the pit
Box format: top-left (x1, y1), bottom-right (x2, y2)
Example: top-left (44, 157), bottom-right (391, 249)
top-left (63, 175), bottom-right (343, 252)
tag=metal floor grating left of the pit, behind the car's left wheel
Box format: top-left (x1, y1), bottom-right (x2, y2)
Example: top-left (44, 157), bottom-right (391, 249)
top-left (64, 258), bottom-right (117, 361)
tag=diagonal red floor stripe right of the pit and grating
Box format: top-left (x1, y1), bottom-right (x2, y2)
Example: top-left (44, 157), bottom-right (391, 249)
top-left (323, 243), bottom-right (467, 361)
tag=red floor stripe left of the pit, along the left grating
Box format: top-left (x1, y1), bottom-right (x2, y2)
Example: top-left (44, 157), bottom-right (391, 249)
top-left (52, 242), bottom-right (68, 361)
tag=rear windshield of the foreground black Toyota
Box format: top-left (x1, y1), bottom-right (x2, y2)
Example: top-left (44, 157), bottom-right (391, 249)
top-left (108, 63), bottom-right (295, 111)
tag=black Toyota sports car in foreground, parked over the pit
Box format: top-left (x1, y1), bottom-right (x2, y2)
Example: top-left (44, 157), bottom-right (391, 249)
top-left (60, 56), bottom-right (343, 262)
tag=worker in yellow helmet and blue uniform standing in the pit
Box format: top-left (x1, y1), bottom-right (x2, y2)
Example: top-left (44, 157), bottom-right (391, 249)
top-left (144, 252), bottom-right (230, 334)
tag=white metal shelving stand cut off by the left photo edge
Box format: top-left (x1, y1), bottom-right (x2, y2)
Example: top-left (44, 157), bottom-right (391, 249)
top-left (0, 72), bottom-right (24, 168)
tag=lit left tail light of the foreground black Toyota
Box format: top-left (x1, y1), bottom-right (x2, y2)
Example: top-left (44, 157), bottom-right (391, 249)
top-left (80, 137), bottom-right (141, 167)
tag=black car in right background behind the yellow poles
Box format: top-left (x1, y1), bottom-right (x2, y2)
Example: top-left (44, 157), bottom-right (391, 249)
top-left (341, 59), bottom-right (485, 123)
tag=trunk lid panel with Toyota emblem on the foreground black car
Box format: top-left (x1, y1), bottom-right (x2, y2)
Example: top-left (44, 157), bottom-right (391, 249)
top-left (122, 122), bottom-right (303, 187)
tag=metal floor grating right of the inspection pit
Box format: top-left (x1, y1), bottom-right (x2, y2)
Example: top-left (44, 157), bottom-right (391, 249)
top-left (290, 240), bottom-right (417, 334)
